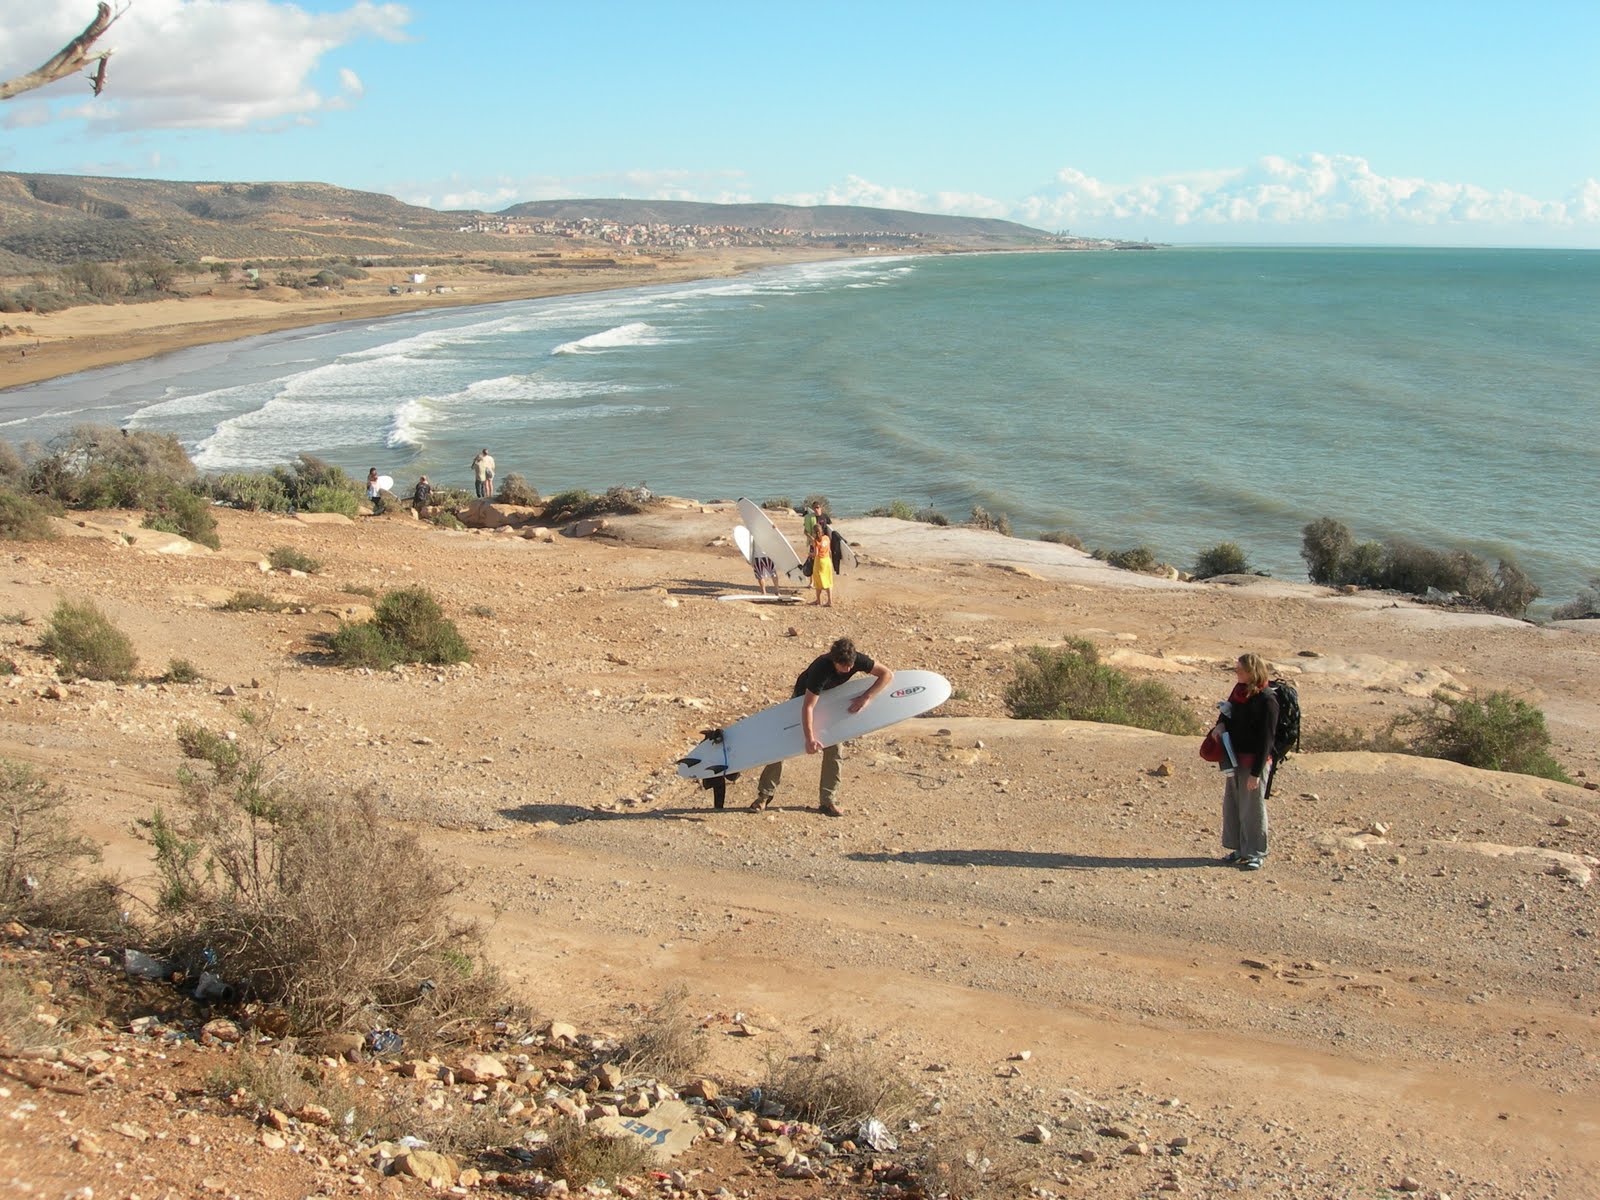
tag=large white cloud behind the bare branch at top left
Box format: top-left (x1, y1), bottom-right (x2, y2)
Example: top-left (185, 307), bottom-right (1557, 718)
top-left (0, 0), bottom-right (411, 130)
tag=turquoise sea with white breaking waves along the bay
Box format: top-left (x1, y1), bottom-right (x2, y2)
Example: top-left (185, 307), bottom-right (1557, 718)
top-left (0, 248), bottom-right (1600, 611)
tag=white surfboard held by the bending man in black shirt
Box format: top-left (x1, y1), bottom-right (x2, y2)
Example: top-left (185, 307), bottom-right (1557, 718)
top-left (678, 670), bottom-right (950, 779)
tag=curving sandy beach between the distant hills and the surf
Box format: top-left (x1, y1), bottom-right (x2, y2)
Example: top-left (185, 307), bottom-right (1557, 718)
top-left (0, 246), bottom-right (857, 395)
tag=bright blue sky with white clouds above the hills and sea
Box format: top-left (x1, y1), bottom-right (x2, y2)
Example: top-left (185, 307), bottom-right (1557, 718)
top-left (0, 0), bottom-right (1600, 248)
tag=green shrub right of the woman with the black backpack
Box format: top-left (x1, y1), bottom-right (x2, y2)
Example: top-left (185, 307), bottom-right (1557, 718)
top-left (1397, 691), bottom-right (1571, 784)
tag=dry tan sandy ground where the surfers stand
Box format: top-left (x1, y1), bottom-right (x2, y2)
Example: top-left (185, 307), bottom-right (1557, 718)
top-left (0, 504), bottom-right (1600, 1200)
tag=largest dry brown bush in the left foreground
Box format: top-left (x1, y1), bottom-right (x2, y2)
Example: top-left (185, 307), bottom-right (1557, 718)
top-left (141, 714), bottom-right (499, 1048)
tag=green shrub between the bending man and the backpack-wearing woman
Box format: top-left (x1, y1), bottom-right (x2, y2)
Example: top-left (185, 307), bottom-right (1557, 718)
top-left (1005, 638), bottom-right (1202, 733)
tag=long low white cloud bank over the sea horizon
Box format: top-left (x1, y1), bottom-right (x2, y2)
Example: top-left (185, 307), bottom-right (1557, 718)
top-left (1014, 154), bottom-right (1600, 240)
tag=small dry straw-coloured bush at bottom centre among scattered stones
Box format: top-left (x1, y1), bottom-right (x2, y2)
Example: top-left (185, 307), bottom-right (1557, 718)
top-left (763, 1026), bottom-right (915, 1126)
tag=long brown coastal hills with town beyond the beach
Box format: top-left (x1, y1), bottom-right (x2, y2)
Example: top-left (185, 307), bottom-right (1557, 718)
top-left (0, 173), bottom-right (1072, 275)
